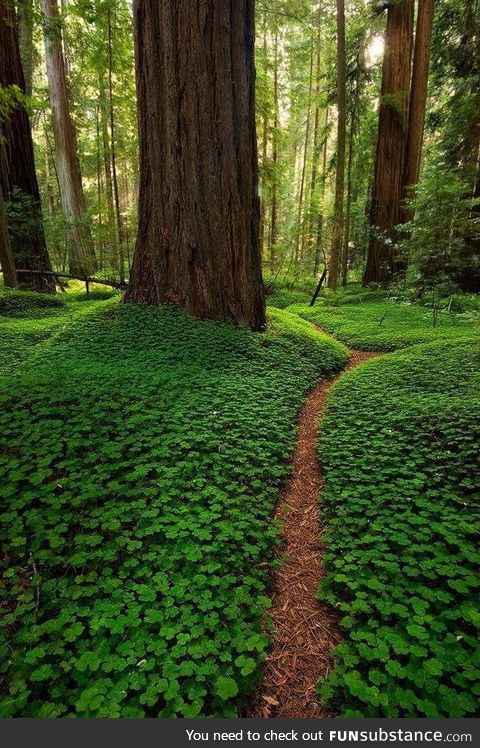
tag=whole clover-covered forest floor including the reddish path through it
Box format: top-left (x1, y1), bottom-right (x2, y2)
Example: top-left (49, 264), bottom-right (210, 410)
top-left (0, 286), bottom-right (480, 718)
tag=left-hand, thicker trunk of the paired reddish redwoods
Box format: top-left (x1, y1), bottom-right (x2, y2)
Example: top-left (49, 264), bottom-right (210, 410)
top-left (363, 0), bottom-right (415, 284)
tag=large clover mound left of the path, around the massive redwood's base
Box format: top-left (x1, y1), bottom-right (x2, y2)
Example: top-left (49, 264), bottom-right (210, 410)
top-left (0, 301), bottom-right (347, 717)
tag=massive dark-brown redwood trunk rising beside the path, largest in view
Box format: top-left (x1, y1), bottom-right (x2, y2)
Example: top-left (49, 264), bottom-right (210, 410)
top-left (126, 0), bottom-right (265, 330)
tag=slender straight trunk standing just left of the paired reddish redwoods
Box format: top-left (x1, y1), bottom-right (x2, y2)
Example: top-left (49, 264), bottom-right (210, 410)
top-left (328, 0), bottom-right (346, 289)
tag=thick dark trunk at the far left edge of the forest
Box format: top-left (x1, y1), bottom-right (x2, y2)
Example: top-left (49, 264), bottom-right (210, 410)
top-left (0, 0), bottom-right (55, 293)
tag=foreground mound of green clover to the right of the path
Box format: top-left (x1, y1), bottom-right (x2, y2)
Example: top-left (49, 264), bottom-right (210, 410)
top-left (319, 342), bottom-right (480, 717)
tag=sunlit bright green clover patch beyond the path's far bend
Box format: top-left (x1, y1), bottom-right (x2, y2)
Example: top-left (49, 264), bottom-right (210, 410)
top-left (288, 295), bottom-right (480, 351)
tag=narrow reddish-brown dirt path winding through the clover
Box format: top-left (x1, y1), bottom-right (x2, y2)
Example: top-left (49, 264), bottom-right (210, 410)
top-left (246, 350), bottom-right (378, 718)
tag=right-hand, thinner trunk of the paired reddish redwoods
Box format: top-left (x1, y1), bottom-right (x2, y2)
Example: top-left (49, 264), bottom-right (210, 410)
top-left (403, 0), bottom-right (435, 221)
